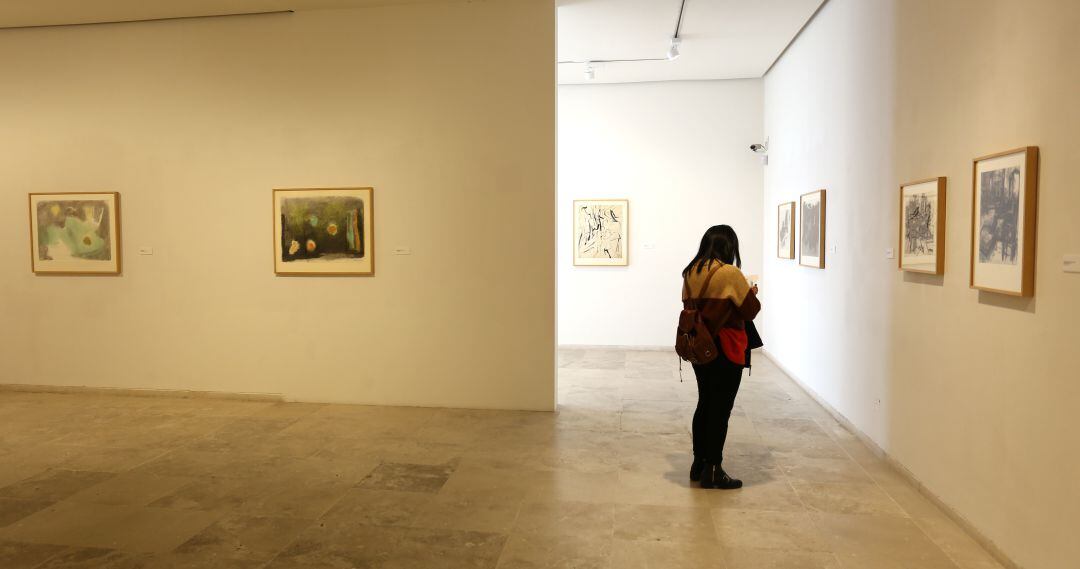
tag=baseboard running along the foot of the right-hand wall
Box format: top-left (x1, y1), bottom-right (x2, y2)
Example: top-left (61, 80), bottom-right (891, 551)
top-left (761, 349), bottom-right (1023, 569)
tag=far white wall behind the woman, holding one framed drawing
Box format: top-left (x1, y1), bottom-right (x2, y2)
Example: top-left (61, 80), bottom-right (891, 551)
top-left (557, 80), bottom-right (764, 347)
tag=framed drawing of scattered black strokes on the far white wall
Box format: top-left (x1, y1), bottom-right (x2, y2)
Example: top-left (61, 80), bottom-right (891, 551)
top-left (573, 200), bottom-right (630, 267)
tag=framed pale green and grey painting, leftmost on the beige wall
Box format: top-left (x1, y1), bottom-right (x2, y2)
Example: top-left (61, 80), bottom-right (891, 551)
top-left (29, 192), bottom-right (123, 275)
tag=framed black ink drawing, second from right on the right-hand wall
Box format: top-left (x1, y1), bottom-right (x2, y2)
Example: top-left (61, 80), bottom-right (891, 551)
top-left (897, 177), bottom-right (946, 274)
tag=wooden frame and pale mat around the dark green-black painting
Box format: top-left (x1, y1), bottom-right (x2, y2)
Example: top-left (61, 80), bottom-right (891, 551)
top-left (273, 188), bottom-right (375, 274)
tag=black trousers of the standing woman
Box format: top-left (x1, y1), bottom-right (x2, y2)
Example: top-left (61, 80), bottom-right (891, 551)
top-left (693, 354), bottom-right (743, 464)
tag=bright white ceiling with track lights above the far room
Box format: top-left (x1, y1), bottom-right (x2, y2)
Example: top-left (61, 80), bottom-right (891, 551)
top-left (557, 0), bottom-right (825, 84)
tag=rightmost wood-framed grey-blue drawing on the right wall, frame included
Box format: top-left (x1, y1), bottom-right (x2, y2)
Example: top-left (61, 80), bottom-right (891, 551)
top-left (971, 146), bottom-right (1039, 297)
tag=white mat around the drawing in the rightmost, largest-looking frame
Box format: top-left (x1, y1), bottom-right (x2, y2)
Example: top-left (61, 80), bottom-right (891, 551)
top-left (971, 151), bottom-right (1027, 293)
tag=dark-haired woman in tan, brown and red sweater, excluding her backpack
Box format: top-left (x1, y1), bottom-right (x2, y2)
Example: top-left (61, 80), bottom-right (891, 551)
top-left (683, 226), bottom-right (761, 489)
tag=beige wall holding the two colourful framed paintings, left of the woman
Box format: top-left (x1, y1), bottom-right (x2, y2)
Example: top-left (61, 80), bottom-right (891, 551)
top-left (0, 0), bottom-right (555, 409)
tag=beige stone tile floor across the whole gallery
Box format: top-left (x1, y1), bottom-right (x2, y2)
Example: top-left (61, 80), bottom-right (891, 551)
top-left (0, 350), bottom-right (1000, 569)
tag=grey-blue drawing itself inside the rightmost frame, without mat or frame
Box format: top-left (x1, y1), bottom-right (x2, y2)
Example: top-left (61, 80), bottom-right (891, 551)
top-left (978, 166), bottom-right (1021, 266)
